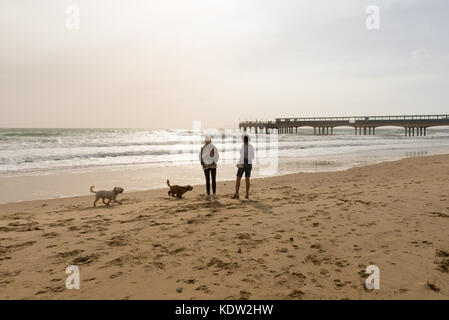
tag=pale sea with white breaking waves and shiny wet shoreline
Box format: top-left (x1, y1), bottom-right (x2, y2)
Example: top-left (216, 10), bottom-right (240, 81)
top-left (0, 127), bottom-right (449, 202)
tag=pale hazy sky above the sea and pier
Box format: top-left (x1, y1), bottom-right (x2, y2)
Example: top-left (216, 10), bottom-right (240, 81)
top-left (0, 0), bottom-right (449, 128)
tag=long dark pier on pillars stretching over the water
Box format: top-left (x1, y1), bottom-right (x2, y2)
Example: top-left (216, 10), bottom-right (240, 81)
top-left (239, 114), bottom-right (449, 137)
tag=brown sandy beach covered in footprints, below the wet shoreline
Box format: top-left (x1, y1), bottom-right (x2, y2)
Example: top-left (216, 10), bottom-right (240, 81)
top-left (0, 155), bottom-right (449, 299)
